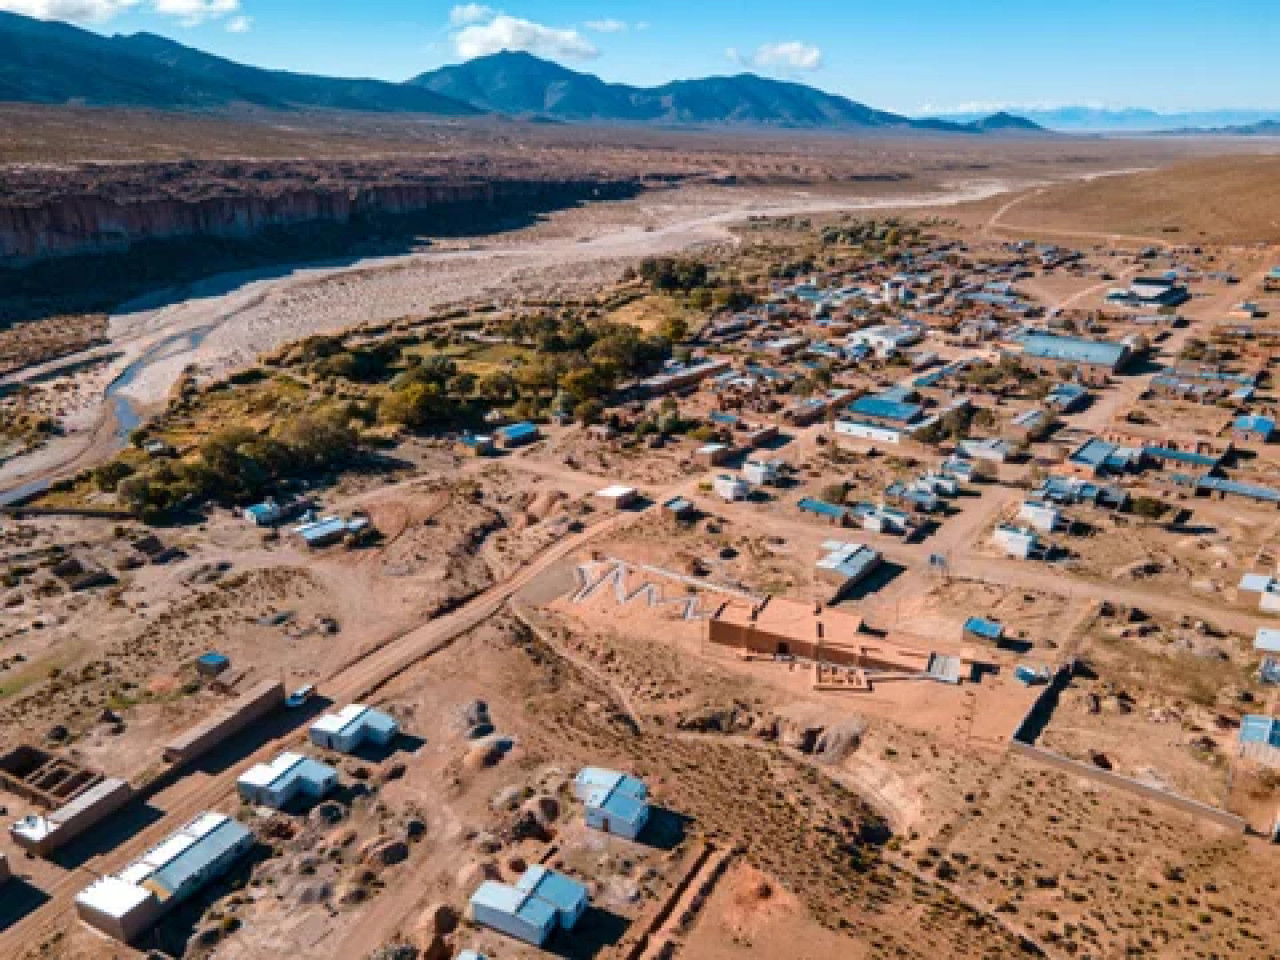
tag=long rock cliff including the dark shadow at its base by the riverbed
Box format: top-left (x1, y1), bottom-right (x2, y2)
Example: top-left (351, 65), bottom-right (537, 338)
top-left (0, 156), bottom-right (640, 325)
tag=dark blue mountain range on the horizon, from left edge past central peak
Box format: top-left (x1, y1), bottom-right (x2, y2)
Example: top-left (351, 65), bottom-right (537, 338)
top-left (0, 13), bottom-right (1038, 134)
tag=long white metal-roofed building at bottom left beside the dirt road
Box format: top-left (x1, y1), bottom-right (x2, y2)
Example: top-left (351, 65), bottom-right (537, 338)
top-left (76, 813), bottom-right (253, 943)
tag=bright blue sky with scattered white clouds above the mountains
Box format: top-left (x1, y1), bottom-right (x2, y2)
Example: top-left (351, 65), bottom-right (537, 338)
top-left (10, 0), bottom-right (1280, 113)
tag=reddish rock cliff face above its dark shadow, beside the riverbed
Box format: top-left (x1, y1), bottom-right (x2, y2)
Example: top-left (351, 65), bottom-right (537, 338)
top-left (0, 164), bottom-right (634, 266)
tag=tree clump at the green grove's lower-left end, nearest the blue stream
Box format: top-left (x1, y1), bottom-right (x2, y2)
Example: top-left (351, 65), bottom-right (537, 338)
top-left (108, 408), bottom-right (360, 522)
